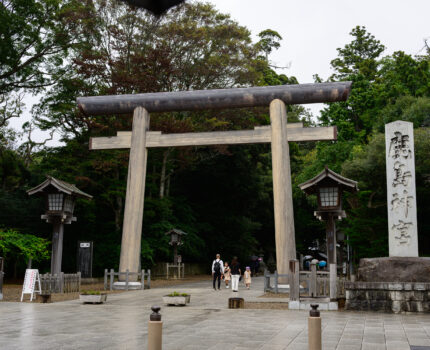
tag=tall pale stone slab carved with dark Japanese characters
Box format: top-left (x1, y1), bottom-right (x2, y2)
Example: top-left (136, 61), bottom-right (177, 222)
top-left (385, 121), bottom-right (418, 257)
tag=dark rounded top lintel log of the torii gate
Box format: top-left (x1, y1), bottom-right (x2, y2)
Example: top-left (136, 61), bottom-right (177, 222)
top-left (76, 81), bottom-right (351, 115)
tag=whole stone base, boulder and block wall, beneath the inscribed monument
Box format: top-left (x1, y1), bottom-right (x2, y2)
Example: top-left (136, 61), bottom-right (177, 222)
top-left (345, 257), bottom-right (430, 313)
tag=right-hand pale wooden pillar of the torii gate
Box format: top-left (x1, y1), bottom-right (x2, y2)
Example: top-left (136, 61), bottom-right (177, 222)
top-left (270, 99), bottom-right (296, 274)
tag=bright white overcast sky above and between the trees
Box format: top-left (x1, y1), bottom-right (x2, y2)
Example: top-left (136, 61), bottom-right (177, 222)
top-left (11, 0), bottom-right (430, 145)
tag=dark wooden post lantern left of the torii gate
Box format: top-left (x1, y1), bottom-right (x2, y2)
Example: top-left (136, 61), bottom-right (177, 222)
top-left (27, 176), bottom-right (93, 274)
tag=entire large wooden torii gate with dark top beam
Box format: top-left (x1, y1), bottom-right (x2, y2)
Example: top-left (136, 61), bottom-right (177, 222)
top-left (77, 82), bottom-right (351, 288)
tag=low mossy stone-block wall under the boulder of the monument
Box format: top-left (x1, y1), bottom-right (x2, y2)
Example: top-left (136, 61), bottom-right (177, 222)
top-left (345, 282), bottom-right (430, 313)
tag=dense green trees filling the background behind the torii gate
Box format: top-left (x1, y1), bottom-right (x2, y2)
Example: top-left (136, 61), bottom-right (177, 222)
top-left (0, 0), bottom-right (430, 274)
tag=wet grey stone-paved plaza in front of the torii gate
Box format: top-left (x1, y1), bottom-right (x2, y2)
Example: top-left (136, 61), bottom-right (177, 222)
top-left (0, 278), bottom-right (430, 350)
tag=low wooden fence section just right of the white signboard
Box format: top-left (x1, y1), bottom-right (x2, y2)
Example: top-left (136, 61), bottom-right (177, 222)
top-left (40, 272), bottom-right (81, 294)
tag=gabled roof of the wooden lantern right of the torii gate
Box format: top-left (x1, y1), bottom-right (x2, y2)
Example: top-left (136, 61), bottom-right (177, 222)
top-left (299, 166), bottom-right (358, 194)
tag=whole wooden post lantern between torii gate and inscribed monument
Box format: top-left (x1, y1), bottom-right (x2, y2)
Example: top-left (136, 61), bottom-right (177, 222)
top-left (299, 167), bottom-right (358, 299)
